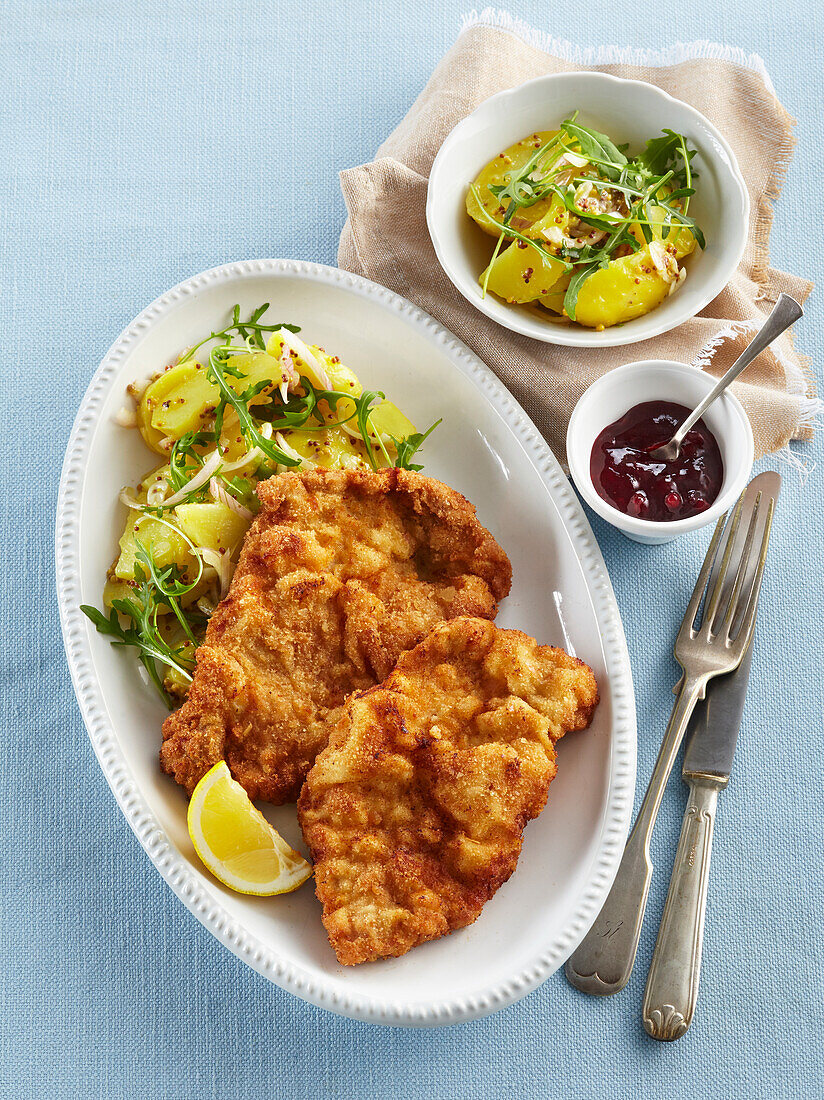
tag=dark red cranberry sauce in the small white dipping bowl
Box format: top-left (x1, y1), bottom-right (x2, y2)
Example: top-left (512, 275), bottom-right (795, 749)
top-left (590, 402), bottom-right (724, 520)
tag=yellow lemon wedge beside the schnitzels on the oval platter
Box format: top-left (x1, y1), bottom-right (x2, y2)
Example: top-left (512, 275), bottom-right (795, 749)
top-left (187, 760), bottom-right (311, 897)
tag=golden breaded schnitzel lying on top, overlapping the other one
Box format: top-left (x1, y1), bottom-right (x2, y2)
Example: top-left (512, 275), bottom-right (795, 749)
top-left (298, 618), bottom-right (598, 965)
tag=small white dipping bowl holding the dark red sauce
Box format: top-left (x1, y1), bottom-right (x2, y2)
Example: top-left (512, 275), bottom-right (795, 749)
top-left (567, 359), bottom-right (755, 543)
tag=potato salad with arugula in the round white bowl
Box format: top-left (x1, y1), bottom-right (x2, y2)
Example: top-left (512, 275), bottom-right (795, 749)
top-left (466, 114), bottom-right (704, 331)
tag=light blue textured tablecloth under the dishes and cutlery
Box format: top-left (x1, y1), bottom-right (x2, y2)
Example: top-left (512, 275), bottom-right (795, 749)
top-left (0, 0), bottom-right (824, 1100)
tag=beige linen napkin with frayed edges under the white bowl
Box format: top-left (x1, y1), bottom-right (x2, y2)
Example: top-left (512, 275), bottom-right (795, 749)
top-left (338, 10), bottom-right (820, 462)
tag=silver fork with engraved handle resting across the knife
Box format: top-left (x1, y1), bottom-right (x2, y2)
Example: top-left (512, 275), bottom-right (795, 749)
top-left (565, 473), bottom-right (780, 997)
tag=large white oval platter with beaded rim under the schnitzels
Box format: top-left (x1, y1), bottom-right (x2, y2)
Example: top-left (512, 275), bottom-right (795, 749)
top-left (55, 260), bottom-right (636, 1026)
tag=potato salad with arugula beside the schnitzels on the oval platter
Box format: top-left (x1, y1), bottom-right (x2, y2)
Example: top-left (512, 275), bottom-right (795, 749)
top-left (83, 305), bottom-right (440, 706)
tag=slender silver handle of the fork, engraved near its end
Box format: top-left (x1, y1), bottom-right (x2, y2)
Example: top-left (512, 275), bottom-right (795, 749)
top-left (564, 677), bottom-right (706, 997)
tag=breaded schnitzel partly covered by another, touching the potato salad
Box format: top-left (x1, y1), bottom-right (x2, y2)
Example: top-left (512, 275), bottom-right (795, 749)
top-left (161, 469), bottom-right (512, 803)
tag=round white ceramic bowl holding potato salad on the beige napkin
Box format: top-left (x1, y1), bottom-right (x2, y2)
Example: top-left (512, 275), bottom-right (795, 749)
top-left (427, 73), bottom-right (749, 348)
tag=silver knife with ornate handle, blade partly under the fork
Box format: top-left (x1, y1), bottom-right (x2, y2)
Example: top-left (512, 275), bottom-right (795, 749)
top-left (641, 642), bottom-right (752, 1042)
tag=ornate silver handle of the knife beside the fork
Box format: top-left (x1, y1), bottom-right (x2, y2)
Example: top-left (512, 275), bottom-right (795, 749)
top-left (641, 777), bottom-right (726, 1043)
